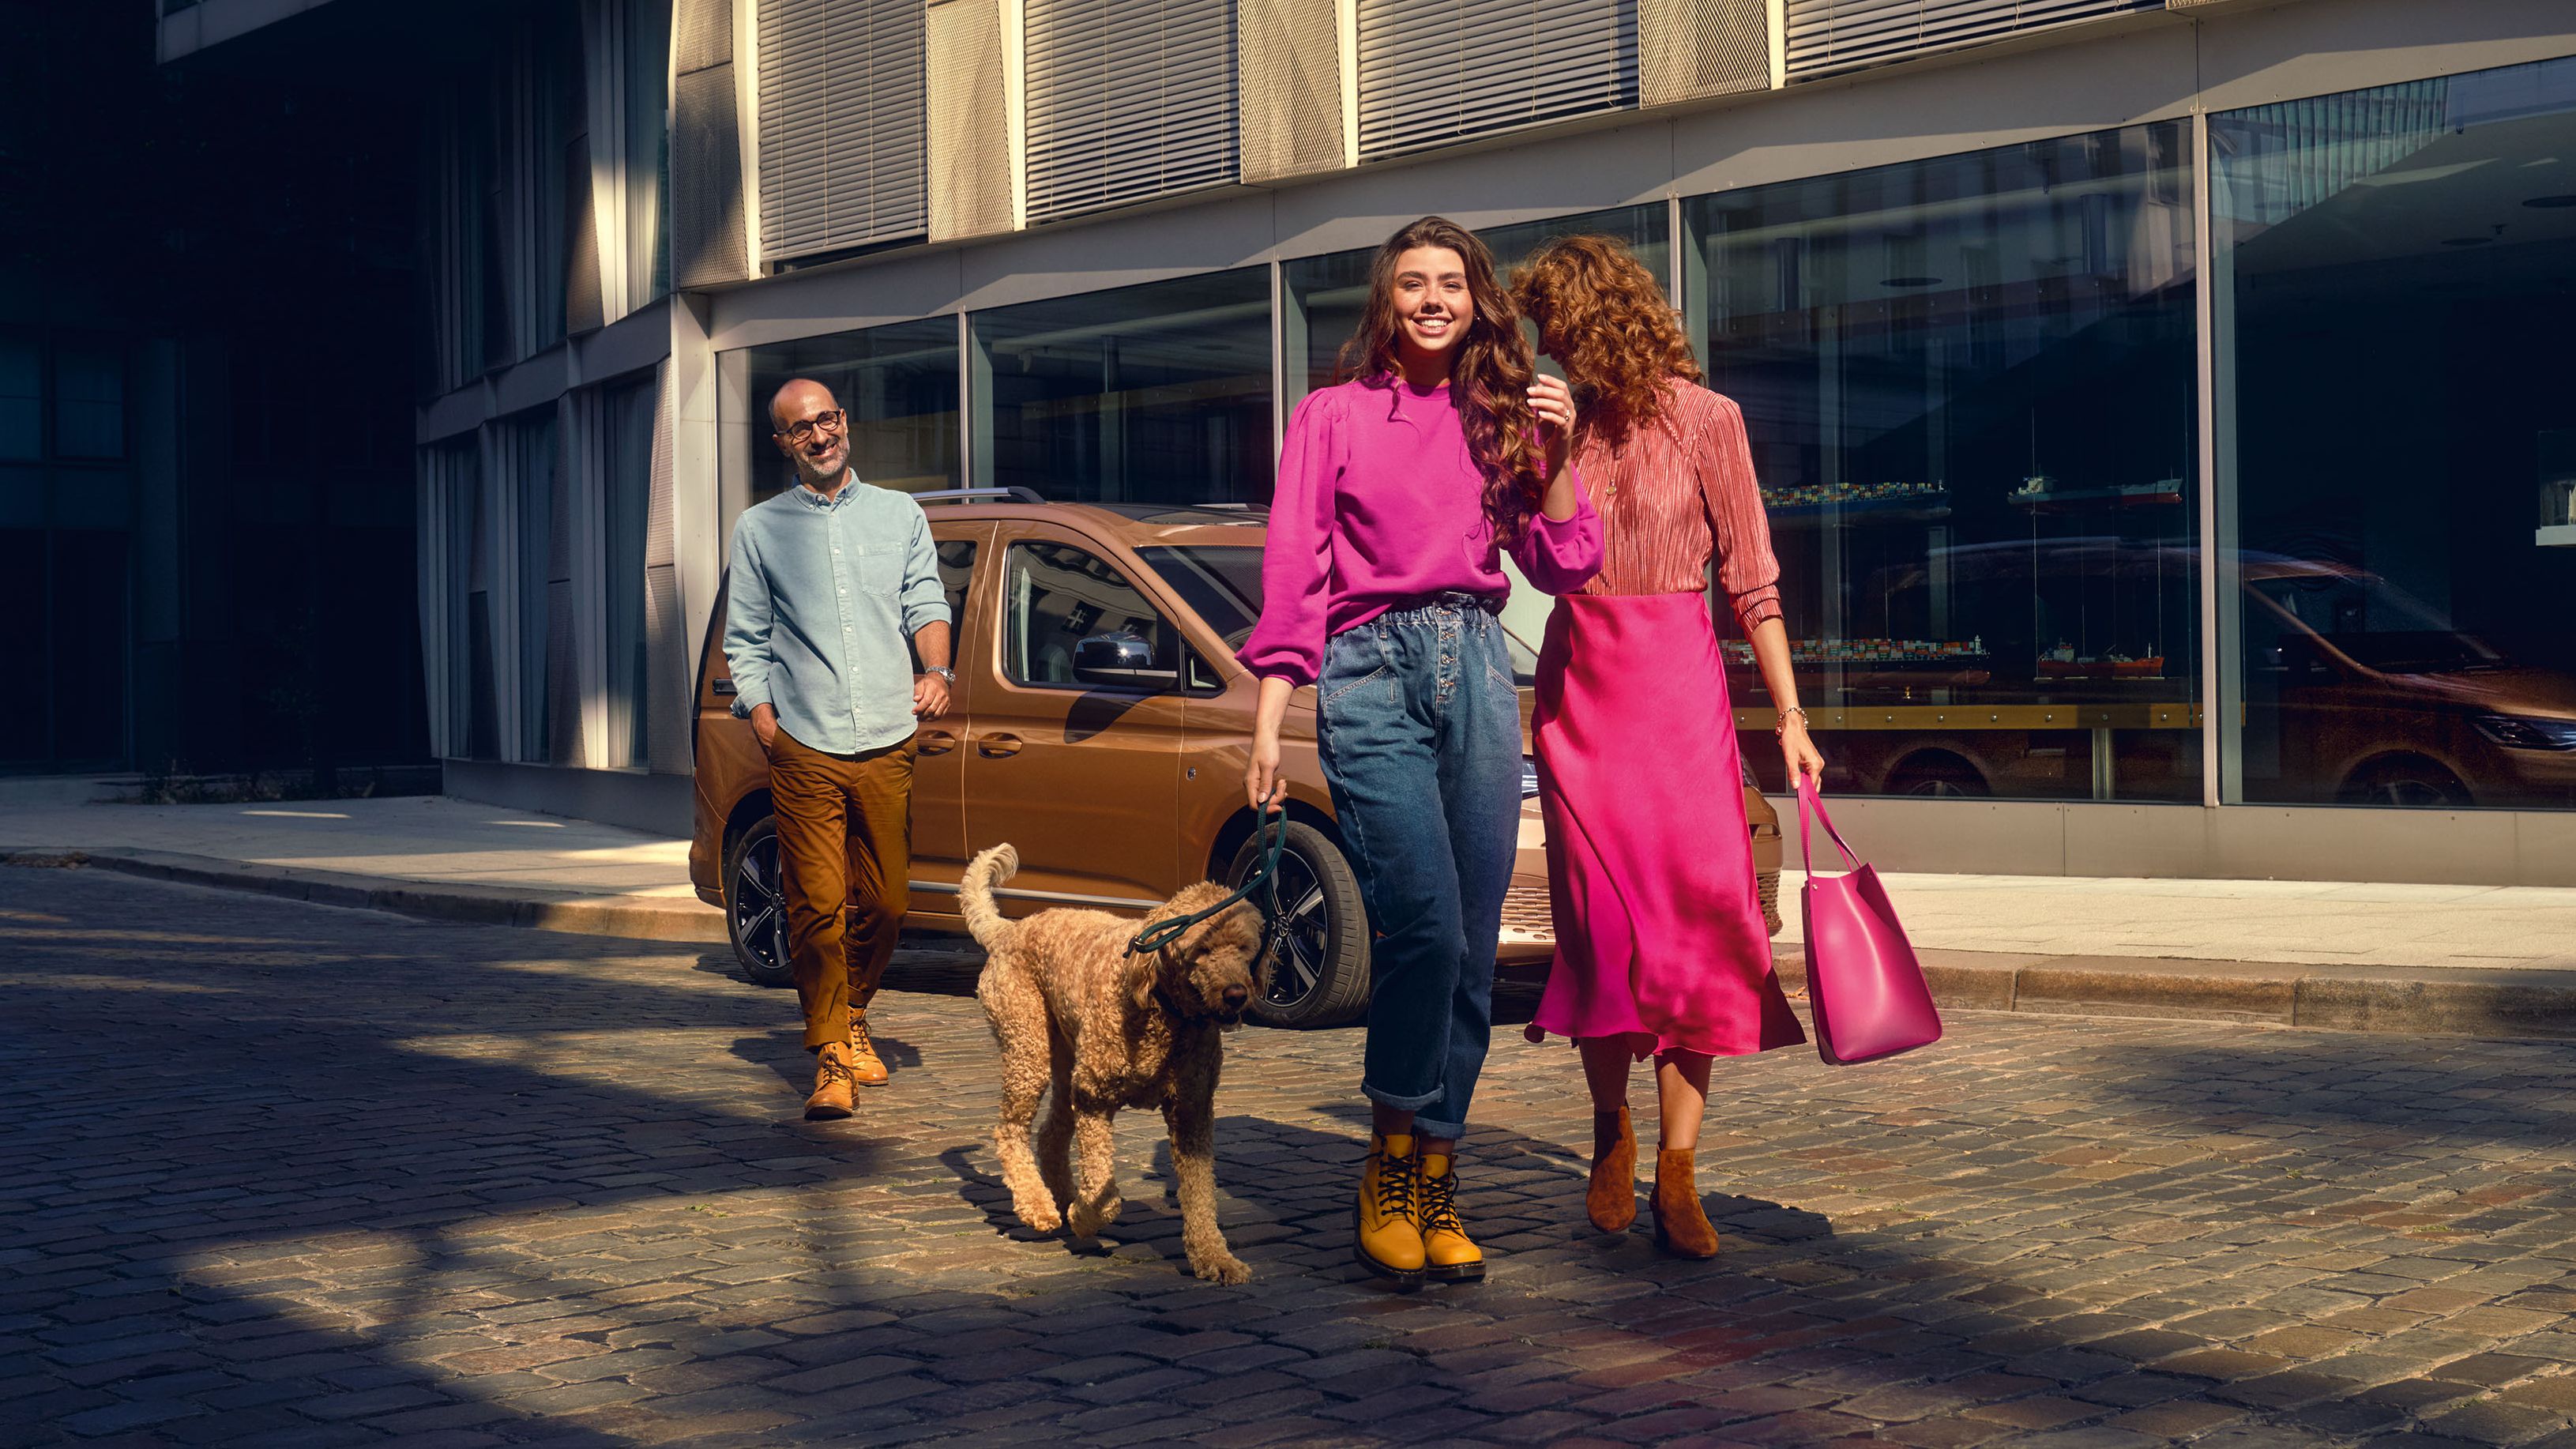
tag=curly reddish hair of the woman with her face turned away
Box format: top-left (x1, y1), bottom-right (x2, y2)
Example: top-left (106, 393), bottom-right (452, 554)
top-left (1512, 237), bottom-right (1700, 446)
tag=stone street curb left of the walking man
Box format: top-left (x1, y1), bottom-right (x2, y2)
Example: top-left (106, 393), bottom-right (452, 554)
top-left (0, 849), bottom-right (727, 943)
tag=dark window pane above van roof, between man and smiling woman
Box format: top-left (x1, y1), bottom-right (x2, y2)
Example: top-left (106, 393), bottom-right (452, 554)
top-left (971, 268), bottom-right (1270, 502)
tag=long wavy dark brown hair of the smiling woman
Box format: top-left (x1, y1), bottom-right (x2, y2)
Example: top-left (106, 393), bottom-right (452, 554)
top-left (1340, 216), bottom-right (1546, 549)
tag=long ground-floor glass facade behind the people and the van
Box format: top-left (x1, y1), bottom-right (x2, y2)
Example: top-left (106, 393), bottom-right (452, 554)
top-left (690, 59), bottom-right (2576, 810)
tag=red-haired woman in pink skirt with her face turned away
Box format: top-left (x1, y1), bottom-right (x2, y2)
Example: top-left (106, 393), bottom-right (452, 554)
top-left (1512, 237), bottom-right (1824, 1259)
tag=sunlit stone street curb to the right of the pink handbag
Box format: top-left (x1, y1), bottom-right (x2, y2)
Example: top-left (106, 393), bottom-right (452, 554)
top-left (1773, 947), bottom-right (2576, 1041)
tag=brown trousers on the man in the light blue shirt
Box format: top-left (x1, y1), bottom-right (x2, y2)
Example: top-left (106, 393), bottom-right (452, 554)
top-left (770, 730), bottom-right (912, 1049)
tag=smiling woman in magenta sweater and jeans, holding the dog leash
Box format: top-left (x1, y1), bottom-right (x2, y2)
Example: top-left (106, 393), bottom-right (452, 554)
top-left (1242, 216), bottom-right (1602, 1284)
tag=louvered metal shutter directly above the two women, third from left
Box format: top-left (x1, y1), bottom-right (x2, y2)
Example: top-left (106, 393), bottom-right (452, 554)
top-left (1360, 0), bottom-right (1636, 157)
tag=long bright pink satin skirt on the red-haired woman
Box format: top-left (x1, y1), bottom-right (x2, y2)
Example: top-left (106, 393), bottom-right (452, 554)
top-left (1528, 593), bottom-right (1806, 1057)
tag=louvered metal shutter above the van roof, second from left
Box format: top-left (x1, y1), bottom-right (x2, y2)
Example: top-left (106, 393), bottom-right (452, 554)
top-left (1028, 0), bottom-right (1239, 222)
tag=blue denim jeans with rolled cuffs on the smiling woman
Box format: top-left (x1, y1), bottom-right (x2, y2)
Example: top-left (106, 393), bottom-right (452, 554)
top-left (1316, 593), bottom-right (1520, 1137)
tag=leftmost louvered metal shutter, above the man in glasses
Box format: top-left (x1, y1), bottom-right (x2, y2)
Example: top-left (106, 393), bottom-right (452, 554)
top-left (760, 0), bottom-right (930, 261)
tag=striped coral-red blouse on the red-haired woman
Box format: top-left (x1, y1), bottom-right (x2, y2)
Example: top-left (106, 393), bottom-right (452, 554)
top-left (1574, 379), bottom-right (1780, 637)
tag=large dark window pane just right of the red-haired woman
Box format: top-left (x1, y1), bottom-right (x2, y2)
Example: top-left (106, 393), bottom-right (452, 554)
top-left (1685, 124), bottom-right (2200, 800)
